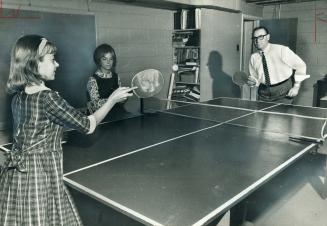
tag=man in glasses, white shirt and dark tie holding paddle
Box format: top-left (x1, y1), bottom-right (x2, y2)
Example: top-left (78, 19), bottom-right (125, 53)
top-left (247, 27), bottom-right (309, 103)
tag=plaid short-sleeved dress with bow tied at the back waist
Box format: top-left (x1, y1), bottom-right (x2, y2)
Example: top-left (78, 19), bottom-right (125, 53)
top-left (0, 90), bottom-right (90, 226)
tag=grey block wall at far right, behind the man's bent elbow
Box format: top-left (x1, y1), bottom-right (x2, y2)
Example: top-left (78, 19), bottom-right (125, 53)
top-left (263, 1), bottom-right (327, 106)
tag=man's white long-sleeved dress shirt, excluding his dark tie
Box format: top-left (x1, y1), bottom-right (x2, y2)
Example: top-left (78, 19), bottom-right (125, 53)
top-left (249, 43), bottom-right (310, 86)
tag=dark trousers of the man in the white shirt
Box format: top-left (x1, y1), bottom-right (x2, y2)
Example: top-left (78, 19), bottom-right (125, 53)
top-left (258, 78), bottom-right (293, 104)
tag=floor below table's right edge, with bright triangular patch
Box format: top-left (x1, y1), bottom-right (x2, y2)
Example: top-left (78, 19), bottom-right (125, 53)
top-left (244, 154), bottom-right (327, 226)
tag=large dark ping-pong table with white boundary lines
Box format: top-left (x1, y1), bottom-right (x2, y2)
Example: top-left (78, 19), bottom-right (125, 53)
top-left (0, 98), bottom-right (327, 226)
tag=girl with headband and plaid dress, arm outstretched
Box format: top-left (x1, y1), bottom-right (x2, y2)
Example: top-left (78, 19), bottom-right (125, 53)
top-left (0, 35), bottom-right (132, 226)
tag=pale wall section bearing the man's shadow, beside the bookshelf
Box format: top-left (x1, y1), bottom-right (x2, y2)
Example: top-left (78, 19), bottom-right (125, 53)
top-left (200, 9), bottom-right (241, 101)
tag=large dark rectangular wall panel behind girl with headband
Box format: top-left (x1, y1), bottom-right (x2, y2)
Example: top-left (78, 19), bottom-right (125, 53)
top-left (0, 9), bottom-right (96, 123)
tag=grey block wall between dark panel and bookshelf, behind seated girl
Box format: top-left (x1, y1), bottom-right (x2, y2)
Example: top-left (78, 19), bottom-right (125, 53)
top-left (3, 0), bottom-right (173, 111)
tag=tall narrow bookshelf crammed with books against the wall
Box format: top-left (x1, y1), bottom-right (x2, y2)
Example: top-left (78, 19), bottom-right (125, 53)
top-left (168, 9), bottom-right (201, 101)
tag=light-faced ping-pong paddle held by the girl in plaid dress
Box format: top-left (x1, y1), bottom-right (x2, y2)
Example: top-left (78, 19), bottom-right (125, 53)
top-left (131, 69), bottom-right (164, 98)
